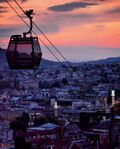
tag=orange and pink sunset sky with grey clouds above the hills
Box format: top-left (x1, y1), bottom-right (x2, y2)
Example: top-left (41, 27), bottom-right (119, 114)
top-left (0, 0), bottom-right (120, 62)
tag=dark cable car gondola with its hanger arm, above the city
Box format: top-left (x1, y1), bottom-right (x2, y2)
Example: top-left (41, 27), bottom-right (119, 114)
top-left (6, 10), bottom-right (42, 69)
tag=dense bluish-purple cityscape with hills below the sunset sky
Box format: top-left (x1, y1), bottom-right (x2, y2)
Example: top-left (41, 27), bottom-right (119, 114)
top-left (0, 46), bottom-right (120, 149)
